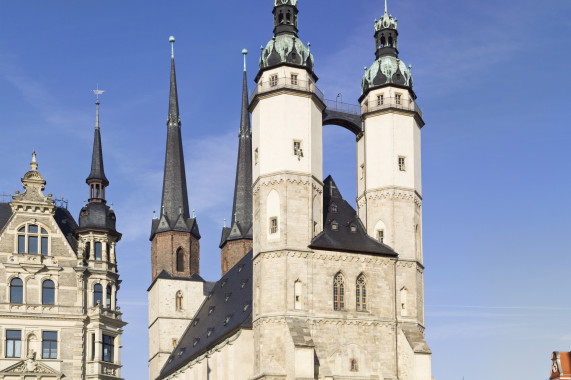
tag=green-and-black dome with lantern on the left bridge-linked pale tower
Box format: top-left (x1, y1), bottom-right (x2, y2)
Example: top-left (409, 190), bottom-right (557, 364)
top-left (260, 0), bottom-right (314, 72)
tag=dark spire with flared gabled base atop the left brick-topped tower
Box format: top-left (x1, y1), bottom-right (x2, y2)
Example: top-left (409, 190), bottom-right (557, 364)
top-left (151, 37), bottom-right (200, 239)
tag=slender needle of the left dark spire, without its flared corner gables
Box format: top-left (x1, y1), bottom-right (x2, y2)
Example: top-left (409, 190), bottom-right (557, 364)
top-left (161, 37), bottom-right (190, 223)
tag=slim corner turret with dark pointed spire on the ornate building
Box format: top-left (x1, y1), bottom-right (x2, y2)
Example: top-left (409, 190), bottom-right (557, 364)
top-left (75, 100), bottom-right (126, 379)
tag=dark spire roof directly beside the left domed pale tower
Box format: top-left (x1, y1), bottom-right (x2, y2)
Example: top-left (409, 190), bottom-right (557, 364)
top-left (220, 50), bottom-right (253, 248)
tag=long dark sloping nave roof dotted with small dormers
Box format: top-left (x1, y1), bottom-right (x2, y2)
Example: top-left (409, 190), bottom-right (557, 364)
top-left (158, 252), bottom-right (253, 379)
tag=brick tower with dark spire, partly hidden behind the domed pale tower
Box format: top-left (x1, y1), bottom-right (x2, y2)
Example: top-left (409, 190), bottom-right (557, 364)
top-left (220, 49), bottom-right (253, 276)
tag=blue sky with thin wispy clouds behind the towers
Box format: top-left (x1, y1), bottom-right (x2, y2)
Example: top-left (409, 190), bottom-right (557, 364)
top-left (0, 0), bottom-right (571, 380)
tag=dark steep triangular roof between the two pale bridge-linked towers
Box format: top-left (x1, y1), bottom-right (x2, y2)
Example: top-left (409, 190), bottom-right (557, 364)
top-left (309, 176), bottom-right (397, 256)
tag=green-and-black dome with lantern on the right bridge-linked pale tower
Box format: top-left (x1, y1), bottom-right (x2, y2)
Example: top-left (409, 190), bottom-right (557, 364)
top-left (361, 1), bottom-right (414, 96)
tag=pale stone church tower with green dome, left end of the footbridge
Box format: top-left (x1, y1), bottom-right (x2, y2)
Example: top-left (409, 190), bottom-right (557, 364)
top-left (250, 0), bottom-right (325, 379)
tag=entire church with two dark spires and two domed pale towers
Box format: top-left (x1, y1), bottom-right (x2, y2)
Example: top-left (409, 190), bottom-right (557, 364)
top-left (149, 0), bottom-right (432, 380)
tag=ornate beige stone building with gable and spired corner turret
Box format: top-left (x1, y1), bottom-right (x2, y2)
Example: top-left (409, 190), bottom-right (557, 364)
top-left (0, 101), bottom-right (126, 380)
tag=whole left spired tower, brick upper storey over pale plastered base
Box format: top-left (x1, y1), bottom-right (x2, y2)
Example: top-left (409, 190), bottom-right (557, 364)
top-left (148, 37), bottom-right (204, 380)
